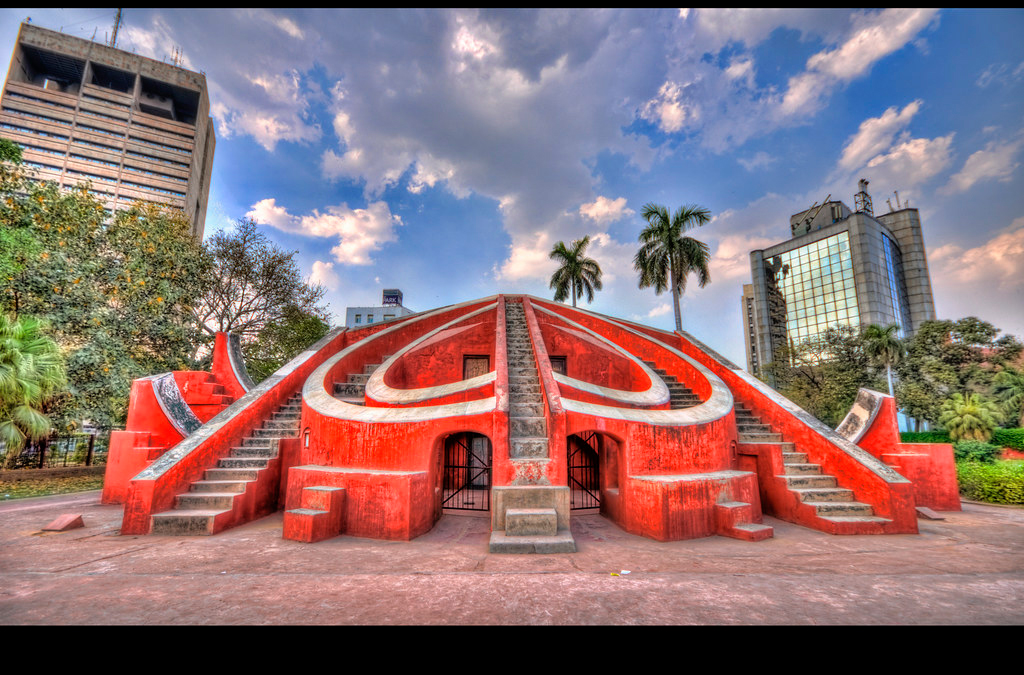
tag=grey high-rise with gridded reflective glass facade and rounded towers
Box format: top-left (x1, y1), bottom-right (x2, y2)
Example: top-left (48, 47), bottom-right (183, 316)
top-left (742, 180), bottom-right (935, 374)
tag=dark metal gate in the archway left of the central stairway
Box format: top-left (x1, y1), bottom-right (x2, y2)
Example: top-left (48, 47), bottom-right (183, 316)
top-left (441, 433), bottom-right (490, 511)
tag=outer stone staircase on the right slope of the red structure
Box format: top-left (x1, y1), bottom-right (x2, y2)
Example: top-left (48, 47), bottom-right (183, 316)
top-left (734, 403), bottom-right (889, 526)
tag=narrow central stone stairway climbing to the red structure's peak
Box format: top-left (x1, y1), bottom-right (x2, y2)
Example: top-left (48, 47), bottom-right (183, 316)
top-left (505, 302), bottom-right (548, 459)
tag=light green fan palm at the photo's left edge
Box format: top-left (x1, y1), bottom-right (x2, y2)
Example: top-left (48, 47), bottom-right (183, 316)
top-left (0, 314), bottom-right (67, 466)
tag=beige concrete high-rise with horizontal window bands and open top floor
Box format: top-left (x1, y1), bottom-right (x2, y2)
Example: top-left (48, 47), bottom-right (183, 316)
top-left (0, 24), bottom-right (215, 239)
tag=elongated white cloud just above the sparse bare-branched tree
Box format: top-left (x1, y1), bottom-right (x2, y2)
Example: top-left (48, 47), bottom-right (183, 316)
top-left (246, 198), bottom-right (401, 265)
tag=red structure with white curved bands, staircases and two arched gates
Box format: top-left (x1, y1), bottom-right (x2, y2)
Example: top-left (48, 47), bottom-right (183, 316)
top-left (104, 295), bottom-right (958, 552)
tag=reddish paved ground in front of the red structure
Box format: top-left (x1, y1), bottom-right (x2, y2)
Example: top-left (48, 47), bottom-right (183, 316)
top-left (0, 492), bottom-right (1024, 625)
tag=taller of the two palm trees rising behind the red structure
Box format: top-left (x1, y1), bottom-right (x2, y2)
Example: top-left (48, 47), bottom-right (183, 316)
top-left (633, 204), bottom-right (711, 331)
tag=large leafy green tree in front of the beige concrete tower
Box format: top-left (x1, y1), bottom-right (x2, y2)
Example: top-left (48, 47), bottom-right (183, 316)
top-left (0, 164), bottom-right (209, 427)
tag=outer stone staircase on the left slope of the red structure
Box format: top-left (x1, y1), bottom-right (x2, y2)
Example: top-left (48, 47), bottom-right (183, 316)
top-left (152, 394), bottom-right (302, 535)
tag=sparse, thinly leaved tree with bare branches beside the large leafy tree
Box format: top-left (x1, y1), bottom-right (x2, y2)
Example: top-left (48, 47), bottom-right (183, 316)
top-left (196, 218), bottom-right (327, 348)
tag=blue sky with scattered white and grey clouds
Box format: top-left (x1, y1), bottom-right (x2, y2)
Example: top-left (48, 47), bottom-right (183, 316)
top-left (0, 9), bottom-right (1024, 364)
